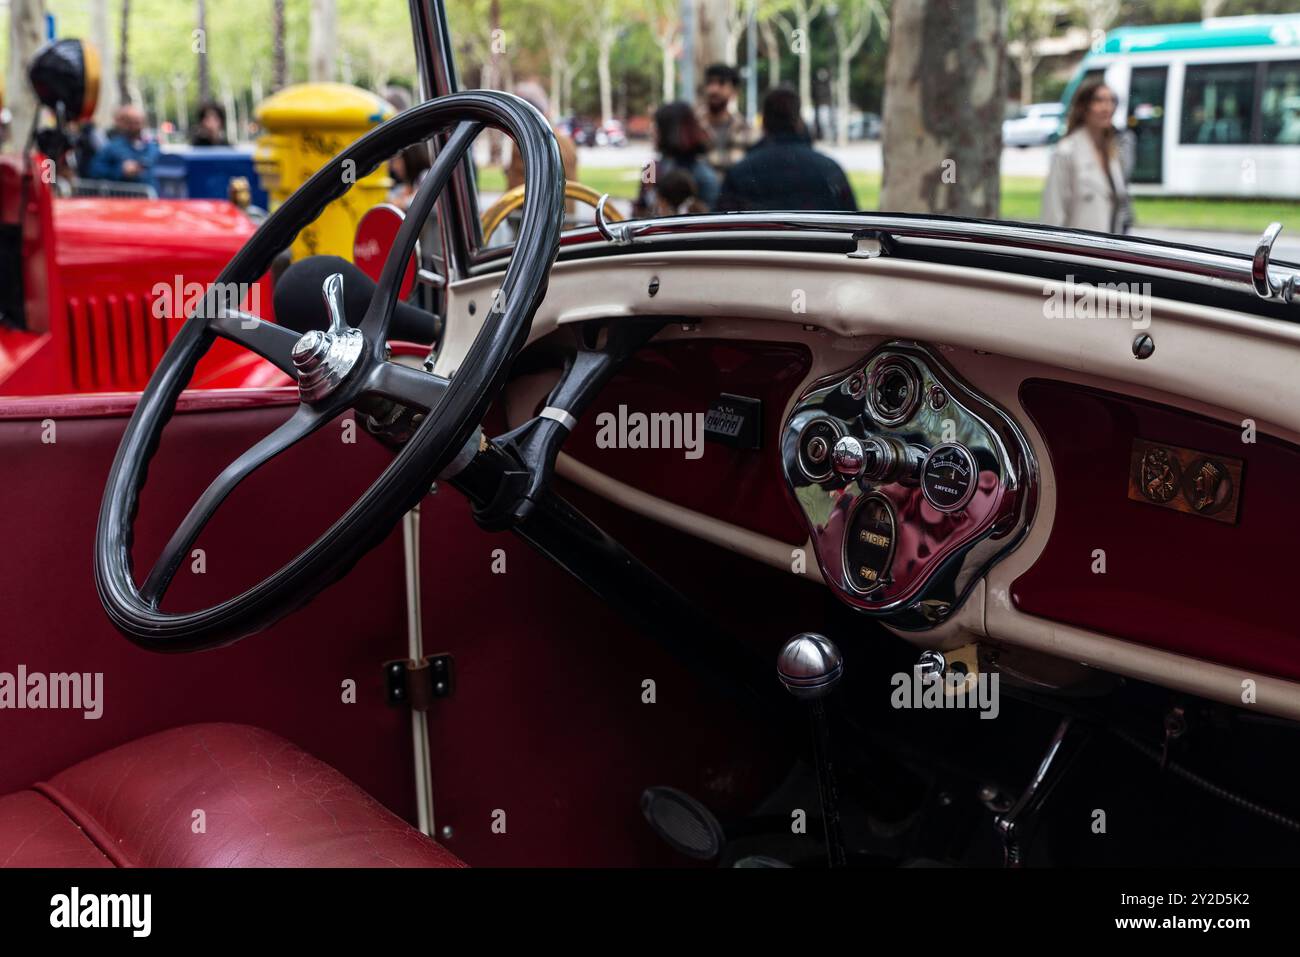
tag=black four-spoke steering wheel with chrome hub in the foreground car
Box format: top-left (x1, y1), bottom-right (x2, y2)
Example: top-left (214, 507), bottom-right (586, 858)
top-left (95, 91), bottom-right (564, 651)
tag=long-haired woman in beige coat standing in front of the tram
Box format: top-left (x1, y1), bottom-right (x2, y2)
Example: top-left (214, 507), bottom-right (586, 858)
top-left (1043, 79), bottom-right (1132, 233)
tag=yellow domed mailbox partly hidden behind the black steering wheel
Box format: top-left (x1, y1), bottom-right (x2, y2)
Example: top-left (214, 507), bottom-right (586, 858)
top-left (254, 83), bottom-right (394, 260)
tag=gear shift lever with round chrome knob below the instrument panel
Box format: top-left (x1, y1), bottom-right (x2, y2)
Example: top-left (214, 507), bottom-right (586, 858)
top-left (776, 632), bottom-right (848, 867)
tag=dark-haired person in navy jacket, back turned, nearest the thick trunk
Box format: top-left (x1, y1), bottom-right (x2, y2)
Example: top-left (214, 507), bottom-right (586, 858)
top-left (716, 87), bottom-right (858, 212)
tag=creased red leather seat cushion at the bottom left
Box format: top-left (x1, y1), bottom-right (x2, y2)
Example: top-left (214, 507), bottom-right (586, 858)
top-left (0, 724), bottom-right (464, 867)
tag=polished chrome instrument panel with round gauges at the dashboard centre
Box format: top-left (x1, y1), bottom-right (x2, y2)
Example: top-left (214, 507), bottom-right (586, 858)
top-left (781, 342), bottom-right (1037, 631)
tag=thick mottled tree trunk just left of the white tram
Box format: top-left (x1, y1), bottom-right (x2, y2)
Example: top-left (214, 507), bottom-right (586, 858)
top-left (880, 0), bottom-right (1006, 217)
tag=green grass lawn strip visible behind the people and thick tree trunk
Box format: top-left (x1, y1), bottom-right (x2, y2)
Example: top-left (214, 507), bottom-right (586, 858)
top-left (478, 166), bottom-right (1300, 234)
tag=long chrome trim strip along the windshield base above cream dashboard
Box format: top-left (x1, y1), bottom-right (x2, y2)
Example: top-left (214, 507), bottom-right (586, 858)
top-left (471, 212), bottom-right (1300, 310)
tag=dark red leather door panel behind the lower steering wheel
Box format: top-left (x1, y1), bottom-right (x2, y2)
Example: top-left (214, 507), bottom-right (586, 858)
top-left (0, 393), bottom-right (415, 819)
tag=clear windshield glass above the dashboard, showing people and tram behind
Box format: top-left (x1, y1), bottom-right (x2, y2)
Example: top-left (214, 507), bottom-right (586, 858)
top-left (447, 0), bottom-right (1300, 259)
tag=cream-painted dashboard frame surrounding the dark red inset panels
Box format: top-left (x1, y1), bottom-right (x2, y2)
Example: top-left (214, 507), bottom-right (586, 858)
top-left (454, 251), bottom-right (1300, 718)
